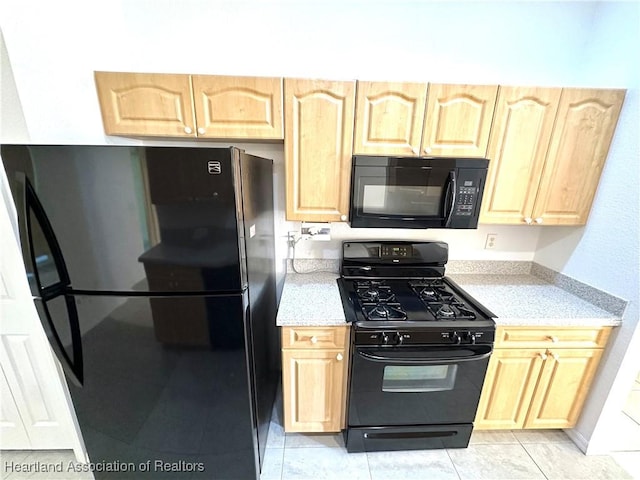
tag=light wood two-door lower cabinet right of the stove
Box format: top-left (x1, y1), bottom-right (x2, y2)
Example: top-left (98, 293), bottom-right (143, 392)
top-left (474, 327), bottom-right (611, 430)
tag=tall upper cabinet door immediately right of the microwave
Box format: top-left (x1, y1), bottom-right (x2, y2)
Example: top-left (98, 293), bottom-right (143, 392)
top-left (480, 87), bottom-right (561, 225)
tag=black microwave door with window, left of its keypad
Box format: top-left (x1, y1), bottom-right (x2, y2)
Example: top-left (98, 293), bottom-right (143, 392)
top-left (350, 157), bottom-right (456, 228)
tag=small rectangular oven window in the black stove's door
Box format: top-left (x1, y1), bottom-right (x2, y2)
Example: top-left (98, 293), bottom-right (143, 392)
top-left (382, 365), bottom-right (458, 392)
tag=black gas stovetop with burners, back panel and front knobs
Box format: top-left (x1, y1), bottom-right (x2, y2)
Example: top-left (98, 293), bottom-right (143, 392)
top-left (338, 241), bottom-right (495, 345)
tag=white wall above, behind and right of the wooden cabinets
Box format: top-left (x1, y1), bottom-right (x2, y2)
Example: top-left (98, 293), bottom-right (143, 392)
top-left (0, 0), bottom-right (639, 450)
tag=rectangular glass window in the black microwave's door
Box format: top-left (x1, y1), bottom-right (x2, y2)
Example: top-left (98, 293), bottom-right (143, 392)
top-left (362, 184), bottom-right (442, 216)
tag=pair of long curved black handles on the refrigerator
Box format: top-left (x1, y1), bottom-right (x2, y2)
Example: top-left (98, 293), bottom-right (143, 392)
top-left (18, 176), bottom-right (83, 385)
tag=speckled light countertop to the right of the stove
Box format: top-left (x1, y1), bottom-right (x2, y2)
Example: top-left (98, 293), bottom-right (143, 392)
top-left (448, 274), bottom-right (621, 326)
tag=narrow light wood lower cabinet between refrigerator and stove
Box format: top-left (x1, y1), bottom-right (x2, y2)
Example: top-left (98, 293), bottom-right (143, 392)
top-left (282, 327), bottom-right (349, 432)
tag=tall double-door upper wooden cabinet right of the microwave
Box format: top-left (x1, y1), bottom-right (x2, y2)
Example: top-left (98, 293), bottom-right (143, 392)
top-left (480, 87), bottom-right (625, 225)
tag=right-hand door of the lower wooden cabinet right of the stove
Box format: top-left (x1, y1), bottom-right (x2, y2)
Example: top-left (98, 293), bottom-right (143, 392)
top-left (524, 349), bottom-right (602, 428)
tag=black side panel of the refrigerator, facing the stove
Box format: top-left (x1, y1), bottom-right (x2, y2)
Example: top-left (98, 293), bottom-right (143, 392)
top-left (238, 153), bottom-right (280, 463)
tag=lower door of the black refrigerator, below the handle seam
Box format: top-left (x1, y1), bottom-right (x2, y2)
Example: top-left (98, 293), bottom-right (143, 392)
top-left (69, 292), bottom-right (259, 480)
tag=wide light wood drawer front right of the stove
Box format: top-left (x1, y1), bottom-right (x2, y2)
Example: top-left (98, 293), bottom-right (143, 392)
top-left (495, 327), bottom-right (611, 348)
